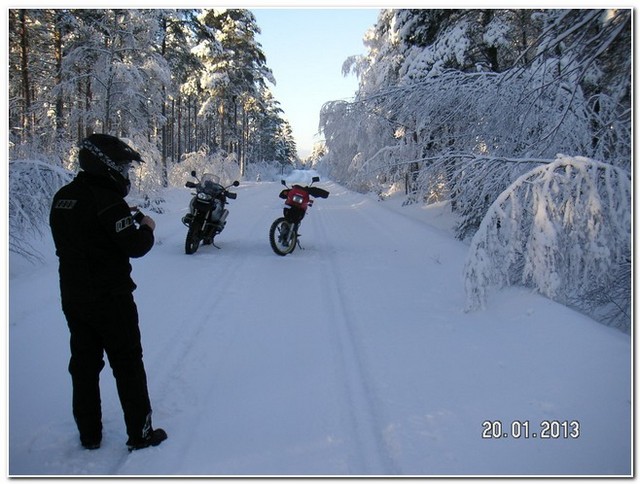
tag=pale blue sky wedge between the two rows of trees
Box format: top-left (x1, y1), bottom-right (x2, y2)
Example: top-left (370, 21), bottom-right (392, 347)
top-left (250, 7), bottom-right (379, 159)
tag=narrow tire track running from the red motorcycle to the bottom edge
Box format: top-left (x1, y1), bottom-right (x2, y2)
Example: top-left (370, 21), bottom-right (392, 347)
top-left (313, 184), bottom-right (401, 475)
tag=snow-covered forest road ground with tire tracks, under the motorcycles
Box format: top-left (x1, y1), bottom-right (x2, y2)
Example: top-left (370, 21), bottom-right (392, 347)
top-left (9, 176), bottom-right (632, 476)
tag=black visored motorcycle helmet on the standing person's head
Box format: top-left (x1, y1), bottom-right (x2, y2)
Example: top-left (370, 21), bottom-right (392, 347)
top-left (78, 134), bottom-right (143, 196)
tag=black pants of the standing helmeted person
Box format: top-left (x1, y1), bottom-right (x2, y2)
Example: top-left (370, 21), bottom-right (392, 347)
top-left (62, 294), bottom-right (151, 444)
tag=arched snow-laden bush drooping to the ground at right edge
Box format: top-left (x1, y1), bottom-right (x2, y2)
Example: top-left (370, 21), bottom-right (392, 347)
top-left (465, 155), bottom-right (631, 329)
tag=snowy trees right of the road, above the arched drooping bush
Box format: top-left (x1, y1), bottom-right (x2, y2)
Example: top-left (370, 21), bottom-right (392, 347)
top-left (321, 10), bottom-right (631, 238)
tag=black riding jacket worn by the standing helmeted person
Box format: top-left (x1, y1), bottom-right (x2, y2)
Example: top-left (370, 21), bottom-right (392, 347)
top-left (49, 172), bottom-right (154, 301)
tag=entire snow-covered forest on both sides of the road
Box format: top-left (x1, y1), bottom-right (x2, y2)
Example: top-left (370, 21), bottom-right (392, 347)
top-left (8, 9), bottom-right (633, 331)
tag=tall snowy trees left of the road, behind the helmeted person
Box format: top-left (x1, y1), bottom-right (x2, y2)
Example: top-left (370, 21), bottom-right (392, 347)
top-left (8, 5), bottom-right (295, 260)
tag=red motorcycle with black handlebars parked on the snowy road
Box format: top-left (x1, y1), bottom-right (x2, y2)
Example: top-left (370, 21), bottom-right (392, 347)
top-left (269, 176), bottom-right (329, 256)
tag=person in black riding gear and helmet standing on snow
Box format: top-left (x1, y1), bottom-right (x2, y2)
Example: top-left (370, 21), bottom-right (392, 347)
top-left (49, 134), bottom-right (167, 451)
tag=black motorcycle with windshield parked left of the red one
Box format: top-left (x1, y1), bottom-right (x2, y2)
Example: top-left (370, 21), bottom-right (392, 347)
top-left (182, 171), bottom-right (240, 254)
